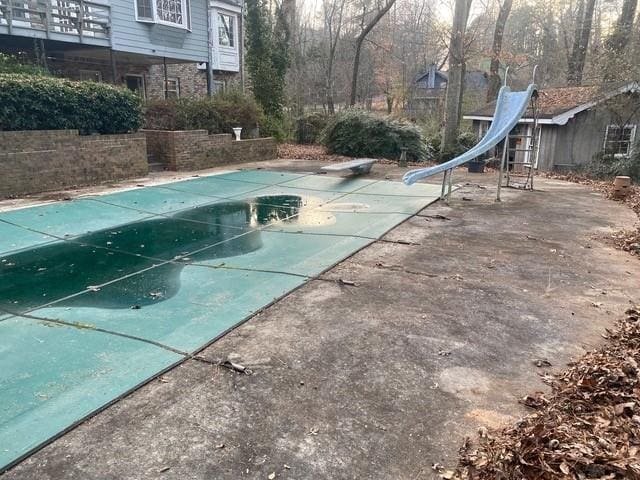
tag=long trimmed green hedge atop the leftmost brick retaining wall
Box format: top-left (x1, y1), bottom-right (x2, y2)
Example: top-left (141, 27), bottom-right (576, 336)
top-left (0, 74), bottom-right (142, 134)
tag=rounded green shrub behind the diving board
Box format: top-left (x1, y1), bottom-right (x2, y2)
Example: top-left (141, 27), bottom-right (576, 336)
top-left (321, 110), bottom-right (431, 161)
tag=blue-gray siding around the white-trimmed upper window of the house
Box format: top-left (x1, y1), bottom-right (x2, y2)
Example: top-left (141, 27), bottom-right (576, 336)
top-left (111, 0), bottom-right (208, 62)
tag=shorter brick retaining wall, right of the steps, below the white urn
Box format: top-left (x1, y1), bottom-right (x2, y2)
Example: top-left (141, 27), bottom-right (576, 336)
top-left (143, 130), bottom-right (278, 170)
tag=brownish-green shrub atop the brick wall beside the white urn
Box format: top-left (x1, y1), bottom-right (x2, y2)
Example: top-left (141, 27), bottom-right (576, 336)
top-left (145, 91), bottom-right (262, 137)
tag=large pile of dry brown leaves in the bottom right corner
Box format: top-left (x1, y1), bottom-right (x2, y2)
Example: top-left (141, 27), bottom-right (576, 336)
top-left (450, 307), bottom-right (640, 480)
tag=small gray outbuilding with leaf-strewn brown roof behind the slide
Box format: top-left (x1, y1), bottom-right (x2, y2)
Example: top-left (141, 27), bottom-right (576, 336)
top-left (463, 82), bottom-right (640, 171)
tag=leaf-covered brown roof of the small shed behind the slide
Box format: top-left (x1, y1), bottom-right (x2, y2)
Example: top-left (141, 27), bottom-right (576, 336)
top-left (464, 82), bottom-right (640, 125)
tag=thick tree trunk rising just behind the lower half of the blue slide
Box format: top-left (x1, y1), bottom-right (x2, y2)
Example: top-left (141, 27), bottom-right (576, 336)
top-left (440, 0), bottom-right (471, 154)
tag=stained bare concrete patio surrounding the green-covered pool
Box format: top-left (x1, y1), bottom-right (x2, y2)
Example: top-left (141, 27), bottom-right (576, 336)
top-left (0, 160), bottom-right (640, 480)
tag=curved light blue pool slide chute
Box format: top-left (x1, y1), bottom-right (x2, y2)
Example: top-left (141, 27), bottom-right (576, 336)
top-left (402, 84), bottom-right (537, 185)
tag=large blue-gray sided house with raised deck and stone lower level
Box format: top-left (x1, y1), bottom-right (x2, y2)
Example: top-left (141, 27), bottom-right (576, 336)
top-left (0, 0), bottom-right (243, 98)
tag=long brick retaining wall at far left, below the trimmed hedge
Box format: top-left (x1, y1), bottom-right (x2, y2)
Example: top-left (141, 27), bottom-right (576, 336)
top-left (0, 130), bottom-right (149, 197)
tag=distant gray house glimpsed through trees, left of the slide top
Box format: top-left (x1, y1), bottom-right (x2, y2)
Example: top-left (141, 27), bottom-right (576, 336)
top-left (409, 64), bottom-right (488, 112)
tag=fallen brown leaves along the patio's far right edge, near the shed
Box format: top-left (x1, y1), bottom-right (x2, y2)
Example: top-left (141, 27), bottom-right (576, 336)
top-left (545, 173), bottom-right (640, 258)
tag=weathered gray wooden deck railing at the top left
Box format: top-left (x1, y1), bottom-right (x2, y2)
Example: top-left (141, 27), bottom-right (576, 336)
top-left (0, 0), bottom-right (111, 41)
